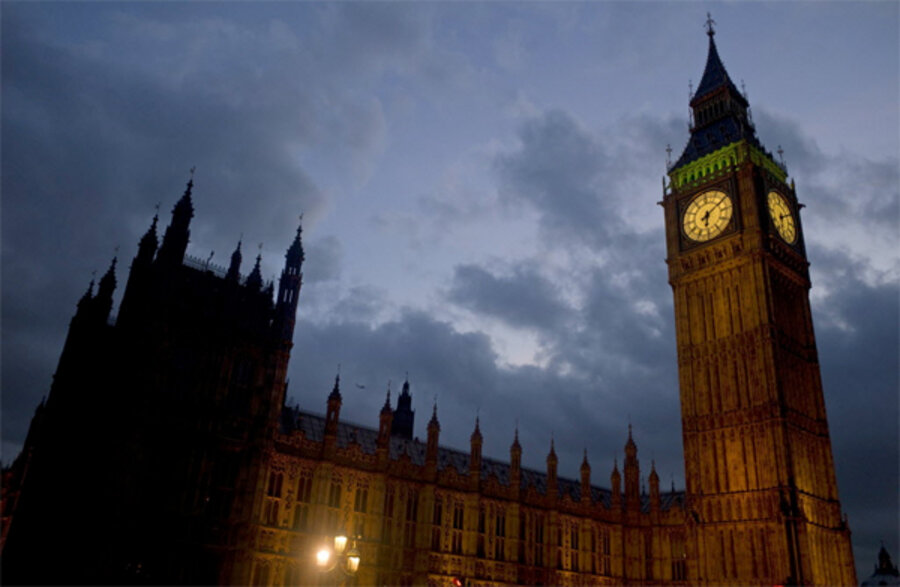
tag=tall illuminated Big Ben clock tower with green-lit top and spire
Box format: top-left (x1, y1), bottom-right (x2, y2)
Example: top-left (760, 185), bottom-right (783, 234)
top-left (663, 20), bottom-right (856, 585)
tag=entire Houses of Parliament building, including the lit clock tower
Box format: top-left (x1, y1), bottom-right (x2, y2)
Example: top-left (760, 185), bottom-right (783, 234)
top-left (2, 22), bottom-right (856, 586)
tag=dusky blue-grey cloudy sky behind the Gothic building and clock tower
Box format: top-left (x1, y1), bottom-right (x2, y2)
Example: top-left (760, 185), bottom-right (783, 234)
top-left (2, 1), bottom-right (900, 578)
